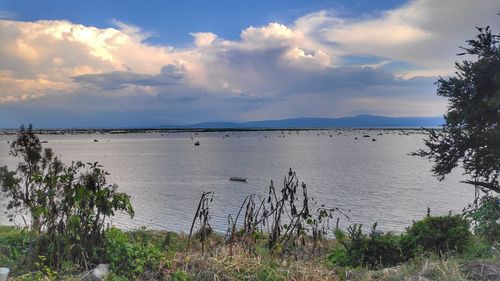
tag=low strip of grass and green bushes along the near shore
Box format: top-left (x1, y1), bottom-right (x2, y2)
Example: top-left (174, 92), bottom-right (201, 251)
top-left (0, 215), bottom-right (500, 280)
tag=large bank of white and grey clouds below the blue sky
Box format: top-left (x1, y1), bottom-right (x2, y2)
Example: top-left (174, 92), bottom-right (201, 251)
top-left (0, 0), bottom-right (500, 126)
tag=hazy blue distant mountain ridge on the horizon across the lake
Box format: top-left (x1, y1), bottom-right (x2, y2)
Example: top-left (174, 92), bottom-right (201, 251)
top-left (162, 115), bottom-right (444, 129)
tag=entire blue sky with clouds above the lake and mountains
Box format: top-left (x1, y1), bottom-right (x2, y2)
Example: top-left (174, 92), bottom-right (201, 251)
top-left (0, 0), bottom-right (500, 128)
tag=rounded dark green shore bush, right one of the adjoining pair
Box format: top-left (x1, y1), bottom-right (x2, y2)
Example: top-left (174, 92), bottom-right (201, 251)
top-left (401, 214), bottom-right (472, 257)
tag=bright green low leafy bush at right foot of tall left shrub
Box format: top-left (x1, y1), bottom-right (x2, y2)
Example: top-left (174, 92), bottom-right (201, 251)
top-left (104, 228), bottom-right (163, 277)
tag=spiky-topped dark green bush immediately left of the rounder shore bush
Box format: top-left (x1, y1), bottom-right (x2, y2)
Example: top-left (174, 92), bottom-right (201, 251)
top-left (328, 224), bottom-right (404, 268)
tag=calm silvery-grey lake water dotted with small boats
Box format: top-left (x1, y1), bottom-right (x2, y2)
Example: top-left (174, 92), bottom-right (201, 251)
top-left (0, 130), bottom-right (474, 232)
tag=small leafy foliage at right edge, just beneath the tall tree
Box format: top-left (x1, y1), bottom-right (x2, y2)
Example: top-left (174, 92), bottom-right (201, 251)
top-left (465, 195), bottom-right (500, 243)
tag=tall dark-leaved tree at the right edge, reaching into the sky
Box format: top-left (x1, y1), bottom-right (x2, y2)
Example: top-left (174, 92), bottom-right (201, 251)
top-left (414, 27), bottom-right (500, 193)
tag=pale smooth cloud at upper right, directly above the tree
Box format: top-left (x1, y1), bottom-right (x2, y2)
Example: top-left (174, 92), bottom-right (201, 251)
top-left (306, 0), bottom-right (500, 76)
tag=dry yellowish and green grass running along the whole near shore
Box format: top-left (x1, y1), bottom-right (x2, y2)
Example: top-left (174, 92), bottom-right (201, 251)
top-left (0, 226), bottom-right (500, 281)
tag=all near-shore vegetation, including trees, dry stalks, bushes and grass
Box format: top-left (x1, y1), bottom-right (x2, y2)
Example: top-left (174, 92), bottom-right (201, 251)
top-left (0, 19), bottom-right (500, 281)
